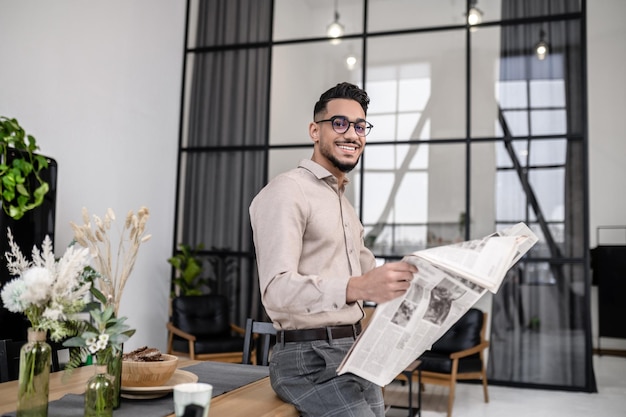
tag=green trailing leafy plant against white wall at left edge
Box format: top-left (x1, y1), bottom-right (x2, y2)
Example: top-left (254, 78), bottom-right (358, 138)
top-left (0, 116), bottom-right (49, 220)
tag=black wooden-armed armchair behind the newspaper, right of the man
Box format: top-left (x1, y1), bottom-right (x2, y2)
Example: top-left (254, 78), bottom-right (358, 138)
top-left (419, 308), bottom-right (489, 417)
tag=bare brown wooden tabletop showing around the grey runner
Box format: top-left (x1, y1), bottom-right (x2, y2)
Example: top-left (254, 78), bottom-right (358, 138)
top-left (0, 358), bottom-right (300, 417)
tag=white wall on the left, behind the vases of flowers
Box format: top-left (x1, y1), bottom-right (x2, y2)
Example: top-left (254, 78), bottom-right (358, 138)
top-left (0, 0), bottom-right (185, 349)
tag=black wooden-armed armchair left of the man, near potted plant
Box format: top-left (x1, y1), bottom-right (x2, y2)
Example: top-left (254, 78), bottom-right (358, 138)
top-left (167, 294), bottom-right (244, 363)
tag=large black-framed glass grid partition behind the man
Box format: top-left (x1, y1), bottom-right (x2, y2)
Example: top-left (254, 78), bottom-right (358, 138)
top-left (176, 0), bottom-right (594, 391)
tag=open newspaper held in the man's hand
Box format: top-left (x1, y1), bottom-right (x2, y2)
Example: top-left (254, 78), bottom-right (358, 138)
top-left (337, 223), bottom-right (538, 386)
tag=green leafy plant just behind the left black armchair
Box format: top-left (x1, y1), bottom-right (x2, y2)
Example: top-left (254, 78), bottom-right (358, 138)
top-left (167, 243), bottom-right (209, 296)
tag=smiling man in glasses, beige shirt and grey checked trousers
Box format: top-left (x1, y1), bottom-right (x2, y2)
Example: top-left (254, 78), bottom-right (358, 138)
top-left (250, 83), bottom-right (417, 417)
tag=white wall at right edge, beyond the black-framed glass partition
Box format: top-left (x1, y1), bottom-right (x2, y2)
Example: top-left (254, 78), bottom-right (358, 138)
top-left (587, 0), bottom-right (626, 349)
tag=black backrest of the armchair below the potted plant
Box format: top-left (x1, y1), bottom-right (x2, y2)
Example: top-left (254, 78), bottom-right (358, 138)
top-left (172, 294), bottom-right (230, 336)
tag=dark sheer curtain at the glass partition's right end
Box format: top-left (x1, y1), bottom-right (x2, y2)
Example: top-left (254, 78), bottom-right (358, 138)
top-left (489, 0), bottom-right (596, 392)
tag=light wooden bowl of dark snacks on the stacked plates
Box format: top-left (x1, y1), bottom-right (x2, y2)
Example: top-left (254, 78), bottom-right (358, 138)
top-left (122, 346), bottom-right (178, 387)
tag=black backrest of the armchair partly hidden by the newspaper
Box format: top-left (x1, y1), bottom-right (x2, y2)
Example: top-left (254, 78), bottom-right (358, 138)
top-left (430, 308), bottom-right (484, 354)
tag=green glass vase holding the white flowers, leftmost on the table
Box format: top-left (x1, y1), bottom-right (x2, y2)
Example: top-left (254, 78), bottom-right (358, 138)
top-left (17, 328), bottom-right (52, 417)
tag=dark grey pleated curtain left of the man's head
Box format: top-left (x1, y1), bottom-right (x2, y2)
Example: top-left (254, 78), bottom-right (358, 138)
top-left (177, 0), bottom-right (273, 325)
